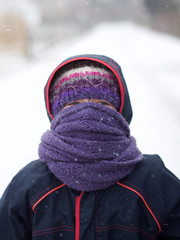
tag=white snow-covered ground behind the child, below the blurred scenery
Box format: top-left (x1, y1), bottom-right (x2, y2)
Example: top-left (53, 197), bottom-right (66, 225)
top-left (0, 22), bottom-right (180, 196)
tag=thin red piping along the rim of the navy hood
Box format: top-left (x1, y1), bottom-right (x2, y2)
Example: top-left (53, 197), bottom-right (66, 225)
top-left (46, 57), bottom-right (125, 119)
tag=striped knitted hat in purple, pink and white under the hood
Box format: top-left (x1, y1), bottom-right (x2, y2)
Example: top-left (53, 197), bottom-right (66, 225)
top-left (49, 60), bottom-right (121, 116)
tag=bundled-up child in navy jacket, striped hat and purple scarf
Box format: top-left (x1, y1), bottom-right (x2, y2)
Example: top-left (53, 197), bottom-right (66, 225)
top-left (0, 55), bottom-right (180, 240)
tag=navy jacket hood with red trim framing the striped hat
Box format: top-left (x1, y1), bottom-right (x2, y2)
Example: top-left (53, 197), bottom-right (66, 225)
top-left (44, 54), bottom-right (132, 124)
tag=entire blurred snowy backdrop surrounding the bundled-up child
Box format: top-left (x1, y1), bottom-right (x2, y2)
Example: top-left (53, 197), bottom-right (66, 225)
top-left (0, 0), bottom-right (180, 195)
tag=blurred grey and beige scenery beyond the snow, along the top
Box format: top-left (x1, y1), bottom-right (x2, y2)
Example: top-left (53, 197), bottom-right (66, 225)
top-left (0, 0), bottom-right (180, 58)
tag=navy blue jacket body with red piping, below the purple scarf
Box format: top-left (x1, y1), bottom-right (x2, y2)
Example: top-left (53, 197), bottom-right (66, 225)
top-left (0, 155), bottom-right (180, 240)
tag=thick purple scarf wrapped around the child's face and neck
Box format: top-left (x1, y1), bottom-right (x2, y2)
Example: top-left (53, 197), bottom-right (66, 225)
top-left (39, 102), bottom-right (143, 191)
